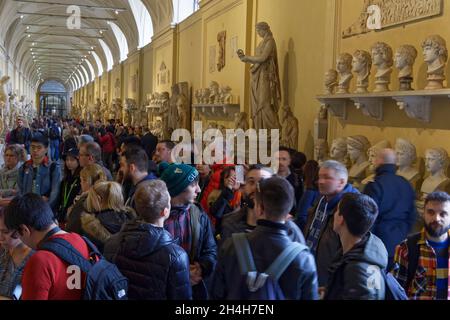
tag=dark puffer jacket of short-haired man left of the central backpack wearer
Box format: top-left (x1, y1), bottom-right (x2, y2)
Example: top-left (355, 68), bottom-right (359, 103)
top-left (104, 221), bottom-right (192, 300)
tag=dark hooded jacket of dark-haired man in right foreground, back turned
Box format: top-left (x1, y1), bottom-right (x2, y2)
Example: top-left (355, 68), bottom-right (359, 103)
top-left (325, 233), bottom-right (388, 300)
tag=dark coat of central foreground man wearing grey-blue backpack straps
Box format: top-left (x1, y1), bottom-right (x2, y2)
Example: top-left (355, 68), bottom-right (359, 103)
top-left (211, 220), bottom-right (318, 300)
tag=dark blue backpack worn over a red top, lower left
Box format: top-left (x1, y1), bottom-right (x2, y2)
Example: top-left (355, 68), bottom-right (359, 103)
top-left (39, 237), bottom-right (128, 300)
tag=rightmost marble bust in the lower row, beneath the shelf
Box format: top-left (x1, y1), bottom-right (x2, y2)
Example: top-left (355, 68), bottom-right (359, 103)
top-left (417, 148), bottom-right (450, 209)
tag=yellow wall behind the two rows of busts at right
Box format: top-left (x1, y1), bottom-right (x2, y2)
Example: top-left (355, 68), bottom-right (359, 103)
top-left (330, 0), bottom-right (450, 160)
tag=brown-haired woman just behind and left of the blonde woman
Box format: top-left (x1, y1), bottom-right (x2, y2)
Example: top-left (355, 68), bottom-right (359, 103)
top-left (65, 164), bottom-right (107, 234)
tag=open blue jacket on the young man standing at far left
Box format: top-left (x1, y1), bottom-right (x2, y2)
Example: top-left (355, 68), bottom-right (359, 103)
top-left (17, 159), bottom-right (61, 212)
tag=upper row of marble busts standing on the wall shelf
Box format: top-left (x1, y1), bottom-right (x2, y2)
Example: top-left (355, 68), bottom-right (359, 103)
top-left (325, 35), bottom-right (448, 94)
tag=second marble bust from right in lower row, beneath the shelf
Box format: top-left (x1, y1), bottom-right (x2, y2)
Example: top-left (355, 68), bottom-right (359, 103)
top-left (395, 138), bottom-right (421, 191)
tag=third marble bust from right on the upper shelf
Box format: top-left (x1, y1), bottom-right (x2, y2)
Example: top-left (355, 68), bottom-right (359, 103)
top-left (371, 42), bottom-right (394, 92)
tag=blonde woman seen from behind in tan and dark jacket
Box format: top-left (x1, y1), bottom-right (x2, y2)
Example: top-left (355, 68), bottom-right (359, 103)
top-left (81, 182), bottom-right (136, 251)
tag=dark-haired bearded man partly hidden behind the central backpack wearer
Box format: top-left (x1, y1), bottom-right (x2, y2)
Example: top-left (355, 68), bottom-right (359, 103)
top-left (219, 165), bottom-right (305, 245)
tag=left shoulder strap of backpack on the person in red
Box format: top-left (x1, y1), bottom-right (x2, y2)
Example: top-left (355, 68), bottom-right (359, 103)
top-left (39, 238), bottom-right (92, 273)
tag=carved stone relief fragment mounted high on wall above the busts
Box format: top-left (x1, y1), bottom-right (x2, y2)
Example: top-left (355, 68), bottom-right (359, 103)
top-left (342, 0), bottom-right (443, 38)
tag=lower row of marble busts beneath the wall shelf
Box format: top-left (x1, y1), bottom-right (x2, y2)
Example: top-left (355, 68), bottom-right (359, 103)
top-left (314, 136), bottom-right (450, 200)
